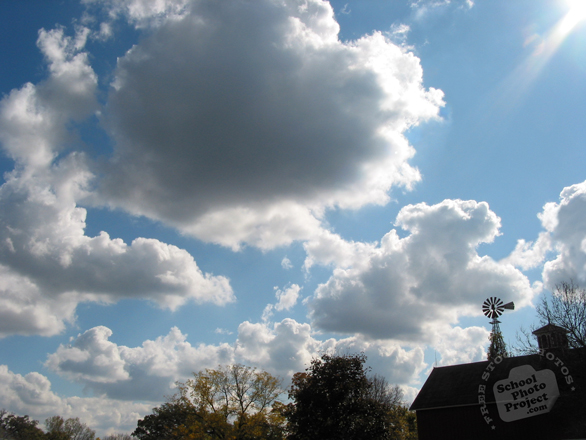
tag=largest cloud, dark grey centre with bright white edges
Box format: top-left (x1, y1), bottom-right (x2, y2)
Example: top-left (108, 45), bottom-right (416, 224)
top-left (96, 0), bottom-right (443, 247)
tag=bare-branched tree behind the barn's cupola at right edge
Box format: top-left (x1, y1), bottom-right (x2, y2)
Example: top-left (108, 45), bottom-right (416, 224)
top-left (516, 280), bottom-right (586, 354)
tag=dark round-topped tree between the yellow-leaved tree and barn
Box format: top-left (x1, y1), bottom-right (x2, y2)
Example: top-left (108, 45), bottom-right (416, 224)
top-left (285, 354), bottom-right (402, 440)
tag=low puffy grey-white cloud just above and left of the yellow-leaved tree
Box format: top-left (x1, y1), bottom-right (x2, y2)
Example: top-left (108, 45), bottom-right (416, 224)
top-left (45, 326), bottom-right (233, 402)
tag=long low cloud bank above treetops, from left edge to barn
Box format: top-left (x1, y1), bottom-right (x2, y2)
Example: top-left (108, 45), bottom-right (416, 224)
top-left (0, 319), bottom-right (427, 432)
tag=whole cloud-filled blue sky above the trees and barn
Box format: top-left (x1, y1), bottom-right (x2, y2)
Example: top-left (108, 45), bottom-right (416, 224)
top-left (0, 0), bottom-right (586, 433)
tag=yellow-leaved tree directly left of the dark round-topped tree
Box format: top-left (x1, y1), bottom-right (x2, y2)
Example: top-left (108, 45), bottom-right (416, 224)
top-left (133, 364), bottom-right (284, 440)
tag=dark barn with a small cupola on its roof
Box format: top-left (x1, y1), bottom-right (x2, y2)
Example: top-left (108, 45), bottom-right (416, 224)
top-left (410, 325), bottom-right (586, 440)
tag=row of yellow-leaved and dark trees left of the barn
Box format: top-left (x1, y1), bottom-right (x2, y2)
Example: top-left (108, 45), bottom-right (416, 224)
top-left (132, 354), bottom-right (417, 440)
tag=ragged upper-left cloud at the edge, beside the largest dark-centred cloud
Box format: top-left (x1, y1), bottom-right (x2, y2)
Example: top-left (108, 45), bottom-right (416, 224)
top-left (0, 28), bottom-right (97, 171)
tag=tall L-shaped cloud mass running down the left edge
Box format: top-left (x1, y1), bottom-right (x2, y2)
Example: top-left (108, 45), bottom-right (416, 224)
top-left (0, 23), bottom-right (234, 336)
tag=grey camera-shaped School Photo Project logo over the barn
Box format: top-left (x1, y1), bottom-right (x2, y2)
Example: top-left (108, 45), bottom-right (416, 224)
top-left (493, 365), bottom-right (560, 422)
